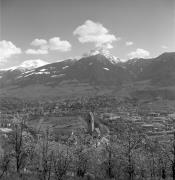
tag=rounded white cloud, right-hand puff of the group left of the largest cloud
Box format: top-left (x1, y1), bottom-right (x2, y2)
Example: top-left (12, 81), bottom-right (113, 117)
top-left (48, 37), bottom-right (71, 52)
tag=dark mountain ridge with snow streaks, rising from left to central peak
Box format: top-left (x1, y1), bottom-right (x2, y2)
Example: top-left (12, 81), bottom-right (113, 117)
top-left (0, 54), bottom-right (130, 86)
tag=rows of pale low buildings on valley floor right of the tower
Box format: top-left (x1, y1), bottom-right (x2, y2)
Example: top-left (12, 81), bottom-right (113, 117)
top-left (101, 108), bottom-right (175, 135)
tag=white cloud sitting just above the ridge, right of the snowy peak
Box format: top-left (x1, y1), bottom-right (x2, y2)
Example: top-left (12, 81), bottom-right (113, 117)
top-left (128, 48), bottom-right (150, 59)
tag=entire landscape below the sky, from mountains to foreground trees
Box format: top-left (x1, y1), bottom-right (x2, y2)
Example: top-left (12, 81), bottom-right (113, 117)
top-left (0, 53), bottom-right (175, 180)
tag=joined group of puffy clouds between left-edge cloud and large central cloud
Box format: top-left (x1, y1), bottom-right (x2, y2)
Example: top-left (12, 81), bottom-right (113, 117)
top-left (25, 37), bottom-right (72, 55)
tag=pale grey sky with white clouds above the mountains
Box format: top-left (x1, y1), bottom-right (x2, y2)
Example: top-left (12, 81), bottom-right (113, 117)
top-left (0, 0), bottom-right (175, 69)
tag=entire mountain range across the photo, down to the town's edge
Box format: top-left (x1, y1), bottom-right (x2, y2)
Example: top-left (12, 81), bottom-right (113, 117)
top-left (0, 51), bottom-right (175, 100)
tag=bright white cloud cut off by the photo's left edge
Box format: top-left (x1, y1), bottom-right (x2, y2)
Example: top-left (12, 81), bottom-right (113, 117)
top-left (0, 40), bottom-right (22, 62)
